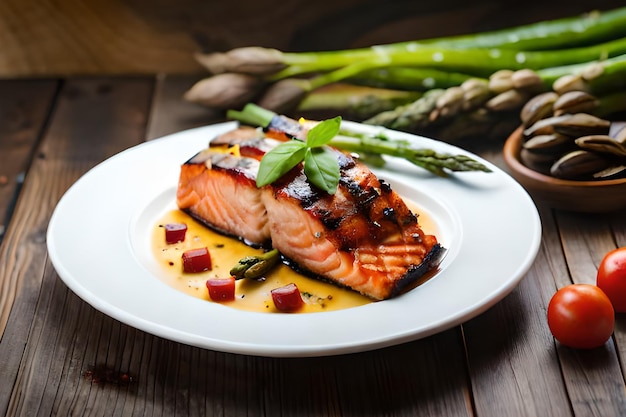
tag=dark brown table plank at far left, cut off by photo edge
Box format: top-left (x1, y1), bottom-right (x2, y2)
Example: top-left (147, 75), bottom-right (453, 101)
top-left (0, 80), bottom-right (59, 244)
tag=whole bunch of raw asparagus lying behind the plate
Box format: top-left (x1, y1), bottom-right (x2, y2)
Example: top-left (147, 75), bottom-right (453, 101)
top-left (185, 7), bottom-right (626, 142)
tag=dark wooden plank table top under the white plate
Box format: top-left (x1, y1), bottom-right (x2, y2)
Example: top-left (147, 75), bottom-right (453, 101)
top-left (0, 76), bottom-right (626, 417)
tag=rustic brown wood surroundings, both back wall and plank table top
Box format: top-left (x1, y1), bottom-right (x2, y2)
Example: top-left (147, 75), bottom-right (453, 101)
top-left (0, 0), bottom-right (626, 417)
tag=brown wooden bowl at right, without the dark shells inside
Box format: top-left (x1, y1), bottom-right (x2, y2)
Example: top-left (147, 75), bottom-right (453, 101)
top-left (503, 127), bottom-right (626, 213)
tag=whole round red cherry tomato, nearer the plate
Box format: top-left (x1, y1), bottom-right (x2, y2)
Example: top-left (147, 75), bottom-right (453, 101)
top-left (548, 284), bottom-right (615, 349)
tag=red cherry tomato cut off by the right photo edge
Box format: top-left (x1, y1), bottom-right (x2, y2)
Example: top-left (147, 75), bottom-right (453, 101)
top-left (596, 247), bottom-right (626, 313)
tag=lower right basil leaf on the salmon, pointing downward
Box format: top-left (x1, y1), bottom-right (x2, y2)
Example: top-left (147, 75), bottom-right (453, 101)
top-left (304, 146), bottom-right (339, 195)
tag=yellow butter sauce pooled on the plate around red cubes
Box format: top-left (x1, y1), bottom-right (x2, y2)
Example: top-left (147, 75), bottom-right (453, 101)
top-left (152, 203), bottom-right (434, 313)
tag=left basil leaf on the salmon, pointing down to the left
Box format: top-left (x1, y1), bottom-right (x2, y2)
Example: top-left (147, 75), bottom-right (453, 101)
top-left (256, 140), bottom-right (307, 187)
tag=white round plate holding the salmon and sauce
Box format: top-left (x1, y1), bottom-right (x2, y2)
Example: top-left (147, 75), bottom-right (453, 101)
top-left (47, 122), bottom-right (541, 357)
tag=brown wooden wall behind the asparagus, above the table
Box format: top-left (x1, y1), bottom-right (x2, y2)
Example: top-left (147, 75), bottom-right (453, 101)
top-left (0, 0), bottom-right (624, 78)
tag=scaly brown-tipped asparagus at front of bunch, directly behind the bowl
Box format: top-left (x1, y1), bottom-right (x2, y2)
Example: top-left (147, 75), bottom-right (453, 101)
top-left (364, 55), bottom-right (626, 143)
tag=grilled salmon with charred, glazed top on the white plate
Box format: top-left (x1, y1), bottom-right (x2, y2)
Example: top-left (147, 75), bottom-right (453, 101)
top-left (176, 122), bottom-right (445, 300)
